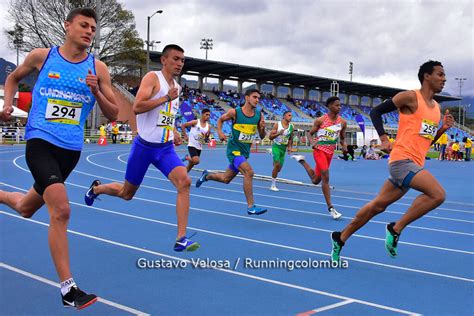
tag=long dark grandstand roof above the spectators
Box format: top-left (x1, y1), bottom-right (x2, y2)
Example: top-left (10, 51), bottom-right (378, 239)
top-left (150, 52), bottom-right (460, 102)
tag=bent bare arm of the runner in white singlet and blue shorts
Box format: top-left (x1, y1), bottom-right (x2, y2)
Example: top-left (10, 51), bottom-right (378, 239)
top-left (133, 72), bottom-right (168, 114)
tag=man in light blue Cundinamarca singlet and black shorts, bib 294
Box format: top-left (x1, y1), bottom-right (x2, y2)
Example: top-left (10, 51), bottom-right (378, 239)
top-left (0, 8), bottom-right (118, 309)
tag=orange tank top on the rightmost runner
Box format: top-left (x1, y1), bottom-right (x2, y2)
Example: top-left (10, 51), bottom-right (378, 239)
top-left (389, 90), bottom-right (441, 167)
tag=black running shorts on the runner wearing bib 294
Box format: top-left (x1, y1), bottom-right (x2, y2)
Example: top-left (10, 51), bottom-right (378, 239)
top-left (26, 138), bottom-right (81, 196)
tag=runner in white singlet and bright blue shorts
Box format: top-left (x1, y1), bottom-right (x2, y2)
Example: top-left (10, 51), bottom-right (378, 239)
top-left (84, 44), bottom-right (199, 251)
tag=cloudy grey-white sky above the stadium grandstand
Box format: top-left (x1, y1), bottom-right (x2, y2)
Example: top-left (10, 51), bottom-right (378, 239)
top-left (0, 0), bottom-right (474, 97)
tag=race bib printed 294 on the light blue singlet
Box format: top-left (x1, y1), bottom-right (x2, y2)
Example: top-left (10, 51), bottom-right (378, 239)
top-left (45, 99), bottom-right (82, 125)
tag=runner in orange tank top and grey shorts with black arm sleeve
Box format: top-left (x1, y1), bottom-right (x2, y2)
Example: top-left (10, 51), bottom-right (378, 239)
top-left (331, 60), bottom-right (454, 262)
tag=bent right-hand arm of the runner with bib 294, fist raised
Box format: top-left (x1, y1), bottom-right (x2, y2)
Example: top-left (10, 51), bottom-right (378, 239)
top-left (92, 60), bottom-right (119, 122)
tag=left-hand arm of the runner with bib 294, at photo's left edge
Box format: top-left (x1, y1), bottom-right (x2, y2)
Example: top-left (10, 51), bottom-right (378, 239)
top-left (0, 48), bottom-right (49, 122)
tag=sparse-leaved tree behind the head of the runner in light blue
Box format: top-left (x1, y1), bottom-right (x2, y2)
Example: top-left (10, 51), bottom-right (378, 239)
top-left (4, 0), bottom-right (146, 75)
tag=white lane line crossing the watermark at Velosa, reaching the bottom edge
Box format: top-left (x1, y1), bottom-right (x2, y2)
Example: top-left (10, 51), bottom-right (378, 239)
top-left (0, 211), bottom-right (422, 315)
